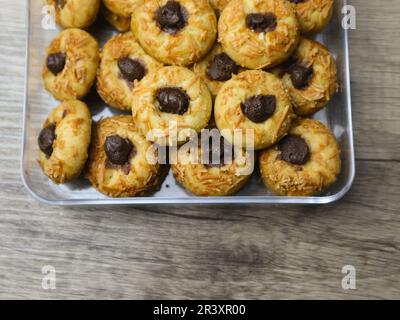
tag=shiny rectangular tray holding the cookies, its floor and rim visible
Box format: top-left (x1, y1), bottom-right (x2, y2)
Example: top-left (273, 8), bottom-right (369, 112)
top-left (21, 0), bottom-right (355, 206)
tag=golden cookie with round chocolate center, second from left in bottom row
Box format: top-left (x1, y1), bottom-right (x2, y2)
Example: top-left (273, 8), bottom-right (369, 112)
top-left (87, 116), bottom-right (168, 197)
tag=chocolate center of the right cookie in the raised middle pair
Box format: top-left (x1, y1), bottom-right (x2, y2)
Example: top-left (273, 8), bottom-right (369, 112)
top-left (241, 95), bottom-right (276, 123)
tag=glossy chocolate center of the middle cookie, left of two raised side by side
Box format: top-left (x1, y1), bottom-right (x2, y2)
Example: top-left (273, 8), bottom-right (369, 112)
top-left (156, 88), bottom-right (190, 115)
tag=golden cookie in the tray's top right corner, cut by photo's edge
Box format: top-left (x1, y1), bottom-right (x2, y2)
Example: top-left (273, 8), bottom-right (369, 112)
top-left (289, 0), bottom-right (334, 33)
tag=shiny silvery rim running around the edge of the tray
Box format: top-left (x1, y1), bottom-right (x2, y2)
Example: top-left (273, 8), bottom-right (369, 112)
top-left (20, 0), bottom-right (356, 207)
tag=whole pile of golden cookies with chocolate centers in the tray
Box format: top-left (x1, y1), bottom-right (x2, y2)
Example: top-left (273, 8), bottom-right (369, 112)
top-left (38, 0), bottom-right (340, 197)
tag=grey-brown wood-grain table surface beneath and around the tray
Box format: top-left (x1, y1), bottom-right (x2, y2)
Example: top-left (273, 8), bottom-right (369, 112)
top-left (0, 0), bottom-right (400, 298)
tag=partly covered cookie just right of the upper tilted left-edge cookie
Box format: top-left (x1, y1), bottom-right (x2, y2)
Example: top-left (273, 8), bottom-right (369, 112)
top-left (97, 32), bottom-right (163, 111)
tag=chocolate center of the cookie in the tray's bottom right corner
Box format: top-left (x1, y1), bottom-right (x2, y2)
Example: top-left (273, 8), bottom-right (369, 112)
top-left (278, 135), bottom-right (310, 165)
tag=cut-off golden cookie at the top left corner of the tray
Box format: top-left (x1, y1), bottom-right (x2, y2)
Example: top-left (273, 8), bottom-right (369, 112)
top-left (45, 0), bottom-right (100, 29)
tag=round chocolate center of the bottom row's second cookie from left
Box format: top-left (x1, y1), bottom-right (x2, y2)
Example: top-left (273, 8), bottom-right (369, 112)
top-left (104, 135), bottom-right (136, 165)
